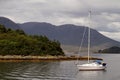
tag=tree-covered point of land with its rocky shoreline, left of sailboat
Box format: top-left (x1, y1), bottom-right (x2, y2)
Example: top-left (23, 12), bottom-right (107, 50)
top-left (0, 25), bottom-right (99, 61)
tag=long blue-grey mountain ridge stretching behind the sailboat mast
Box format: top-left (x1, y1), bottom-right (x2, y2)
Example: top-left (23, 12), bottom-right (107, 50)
top-left (19, 22), bottom-right (120, 51)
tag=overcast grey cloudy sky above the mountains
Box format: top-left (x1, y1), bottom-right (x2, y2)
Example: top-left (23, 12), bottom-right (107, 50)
top-left (0, 0), bottom-right (120, 41)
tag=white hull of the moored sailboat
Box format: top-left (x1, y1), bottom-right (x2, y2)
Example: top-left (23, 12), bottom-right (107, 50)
top-left (77, 63), bottom-right (106, 71)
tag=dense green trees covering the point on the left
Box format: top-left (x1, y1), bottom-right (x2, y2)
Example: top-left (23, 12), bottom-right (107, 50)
top-left (0, 25), bottom-right (64, 56)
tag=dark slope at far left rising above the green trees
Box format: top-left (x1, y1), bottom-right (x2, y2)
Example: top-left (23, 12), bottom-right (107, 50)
top-left (0, 17), bottom-right (20, 30)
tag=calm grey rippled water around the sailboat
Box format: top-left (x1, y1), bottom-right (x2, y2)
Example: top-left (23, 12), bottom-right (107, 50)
top-left (0, 54), bottom-right (120, 80)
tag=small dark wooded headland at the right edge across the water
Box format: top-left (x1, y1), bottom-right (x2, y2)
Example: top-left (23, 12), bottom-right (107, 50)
top-left (98, 46), bottom-right (120, 53)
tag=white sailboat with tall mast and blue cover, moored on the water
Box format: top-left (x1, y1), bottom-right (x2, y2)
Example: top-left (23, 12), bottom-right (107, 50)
top-left (77, 11), bottom-right (106, 71)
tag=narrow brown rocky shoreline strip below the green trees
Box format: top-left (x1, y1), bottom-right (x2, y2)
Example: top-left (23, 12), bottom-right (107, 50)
top-left (0, 55), bottom-right (102, 62)
